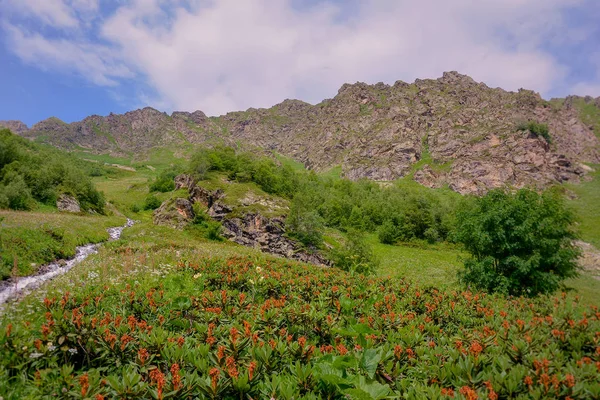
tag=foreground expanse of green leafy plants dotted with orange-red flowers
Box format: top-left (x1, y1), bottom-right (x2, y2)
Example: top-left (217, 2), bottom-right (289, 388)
top-left (0, 255), bottom-right (600, 399)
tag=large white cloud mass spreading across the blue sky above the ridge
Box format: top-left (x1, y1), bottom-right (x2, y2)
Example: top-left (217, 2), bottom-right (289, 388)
top-left (1, 0), bottom-right (596, 114)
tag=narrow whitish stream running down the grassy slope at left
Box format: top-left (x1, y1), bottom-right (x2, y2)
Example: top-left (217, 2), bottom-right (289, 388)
top-left (0, 218), bottom-right (134, 307)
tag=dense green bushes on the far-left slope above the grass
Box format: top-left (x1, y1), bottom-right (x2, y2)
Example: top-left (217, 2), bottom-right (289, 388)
top-left (0, 129), bottom-right (104, 213)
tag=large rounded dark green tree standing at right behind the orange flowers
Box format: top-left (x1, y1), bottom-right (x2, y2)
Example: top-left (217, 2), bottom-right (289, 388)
top-left (455, 189), bottom-right (580, 296)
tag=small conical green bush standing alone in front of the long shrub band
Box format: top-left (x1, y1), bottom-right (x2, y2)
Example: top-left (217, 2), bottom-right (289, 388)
top-left (330, 230), bottom-right (379, 274)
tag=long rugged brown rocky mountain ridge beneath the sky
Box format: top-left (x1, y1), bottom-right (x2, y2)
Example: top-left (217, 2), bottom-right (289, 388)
top-left (5, 72), bottom-right (600, 193)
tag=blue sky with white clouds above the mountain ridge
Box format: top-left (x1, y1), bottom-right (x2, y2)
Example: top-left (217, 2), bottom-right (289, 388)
top-left (0, 0), bottom-right (600, 126)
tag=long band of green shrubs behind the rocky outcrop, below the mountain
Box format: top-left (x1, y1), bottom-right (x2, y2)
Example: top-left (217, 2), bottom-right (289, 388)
top-left (190, 147), bottom-right (459, 246)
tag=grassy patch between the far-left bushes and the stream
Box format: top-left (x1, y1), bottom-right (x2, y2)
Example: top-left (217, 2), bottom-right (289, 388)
top-left (0, 211), bottom-right (125, 279)
